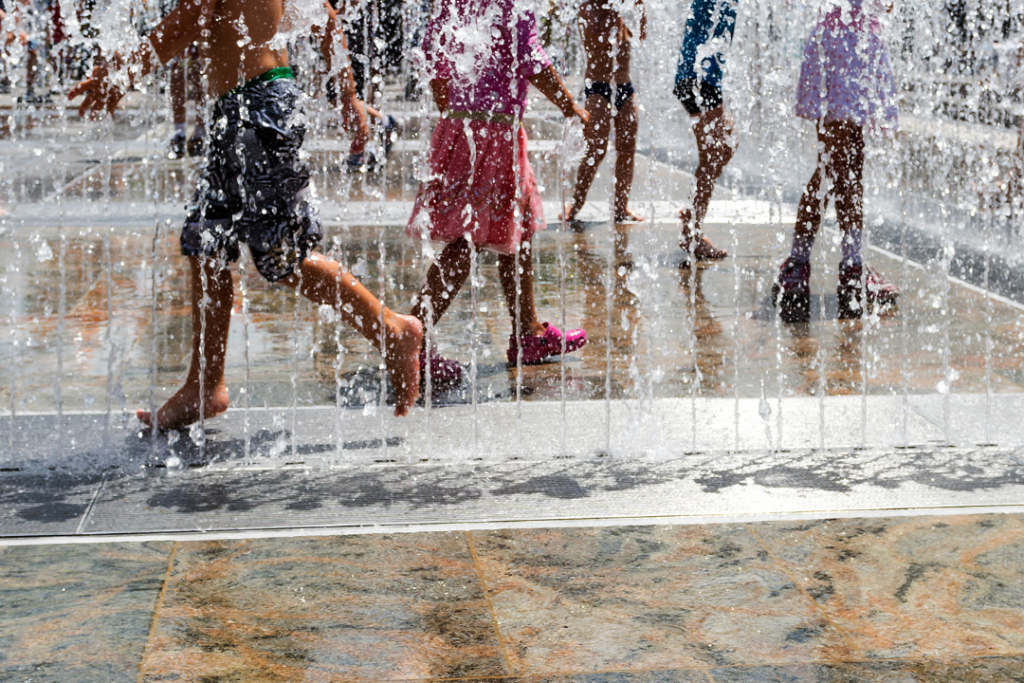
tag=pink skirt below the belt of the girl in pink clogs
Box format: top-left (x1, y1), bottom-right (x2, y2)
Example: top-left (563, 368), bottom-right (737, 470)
top-left (406, 118), bottom-right (545, 254)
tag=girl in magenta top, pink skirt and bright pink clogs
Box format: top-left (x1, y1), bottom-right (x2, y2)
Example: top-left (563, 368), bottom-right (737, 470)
top-left (407, 0), bottom-right (587, 374)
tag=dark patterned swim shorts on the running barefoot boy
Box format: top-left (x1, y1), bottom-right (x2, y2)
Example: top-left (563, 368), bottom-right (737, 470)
top-left (181, 79), bottom-right (323, 283)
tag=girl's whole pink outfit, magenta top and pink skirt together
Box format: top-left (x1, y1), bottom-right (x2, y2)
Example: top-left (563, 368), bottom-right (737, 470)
top-left (406, 0), bottom-right (551, 254)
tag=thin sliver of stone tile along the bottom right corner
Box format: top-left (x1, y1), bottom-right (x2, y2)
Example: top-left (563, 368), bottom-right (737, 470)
top-left (709, 657), bottom-right (1024, 683)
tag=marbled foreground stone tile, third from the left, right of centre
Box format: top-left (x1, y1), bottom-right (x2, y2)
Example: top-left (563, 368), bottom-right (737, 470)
top-left (471, 525), bottom-right (845, 675)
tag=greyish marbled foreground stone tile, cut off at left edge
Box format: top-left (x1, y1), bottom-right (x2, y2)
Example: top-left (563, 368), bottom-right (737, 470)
top-left (0, 543), bottom-right (171, 683)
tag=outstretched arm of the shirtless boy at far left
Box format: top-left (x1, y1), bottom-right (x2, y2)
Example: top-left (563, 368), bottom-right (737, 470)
top-left (68, 0), bottom-right (218, 116)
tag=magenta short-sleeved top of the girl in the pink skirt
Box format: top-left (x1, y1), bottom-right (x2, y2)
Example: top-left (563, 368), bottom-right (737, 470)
top-left (423, 0), bottom-right (551, 117)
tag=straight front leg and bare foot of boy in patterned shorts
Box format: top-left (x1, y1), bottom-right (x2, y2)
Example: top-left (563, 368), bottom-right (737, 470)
top-left (136, 256), bottom-right (234, 430)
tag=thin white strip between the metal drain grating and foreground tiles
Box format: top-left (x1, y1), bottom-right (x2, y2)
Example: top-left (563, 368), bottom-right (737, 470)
top-left (0, 504), bottom-right (1024, 548)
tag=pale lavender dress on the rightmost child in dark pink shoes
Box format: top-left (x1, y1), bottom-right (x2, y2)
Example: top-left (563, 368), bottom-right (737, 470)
top-left (797, 0), bottom-right (899, 131)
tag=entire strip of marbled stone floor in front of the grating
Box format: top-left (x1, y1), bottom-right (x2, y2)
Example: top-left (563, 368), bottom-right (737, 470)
top-left (0, 514), bottom-right (1024, 683)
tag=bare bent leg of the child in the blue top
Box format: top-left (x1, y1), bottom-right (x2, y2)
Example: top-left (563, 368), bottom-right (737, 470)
top-left (679, 106), bottom-right (732, 260)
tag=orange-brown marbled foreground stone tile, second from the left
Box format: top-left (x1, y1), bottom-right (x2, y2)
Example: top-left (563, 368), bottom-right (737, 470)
top-left (142, 532), bottom-right (507, 682)
